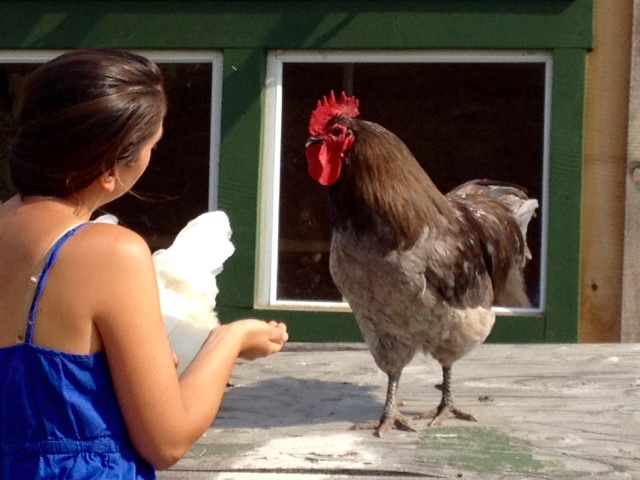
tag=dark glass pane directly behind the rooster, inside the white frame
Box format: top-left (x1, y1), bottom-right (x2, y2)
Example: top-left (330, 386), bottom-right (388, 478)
top-left (277, 62), bottom-right (546, 305)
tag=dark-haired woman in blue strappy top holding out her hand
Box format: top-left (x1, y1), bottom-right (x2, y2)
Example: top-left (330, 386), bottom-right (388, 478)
top-left (0, 49), bottom-right (288, 479)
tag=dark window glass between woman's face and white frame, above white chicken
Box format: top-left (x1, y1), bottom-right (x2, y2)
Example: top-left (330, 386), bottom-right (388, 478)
top-left (104, 63), bottom-right (212, 250)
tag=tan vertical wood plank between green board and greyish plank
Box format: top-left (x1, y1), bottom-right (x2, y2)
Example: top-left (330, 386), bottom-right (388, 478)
top-left (580, 0), bottom-right (633, 342)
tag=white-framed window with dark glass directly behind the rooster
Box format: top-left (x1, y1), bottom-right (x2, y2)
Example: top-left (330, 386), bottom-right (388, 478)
top-left (257, 51), bottom-right (552, 314)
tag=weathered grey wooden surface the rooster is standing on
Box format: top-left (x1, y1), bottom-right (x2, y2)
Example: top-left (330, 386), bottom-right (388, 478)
top-left (159, 344), bottom-right (640, 480)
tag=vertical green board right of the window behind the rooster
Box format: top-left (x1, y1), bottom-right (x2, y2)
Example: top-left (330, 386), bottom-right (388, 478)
top-left (544, 49), bottom-right (586, 342)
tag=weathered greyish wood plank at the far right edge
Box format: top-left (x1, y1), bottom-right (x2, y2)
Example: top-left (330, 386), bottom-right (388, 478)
top-left (620, 0), bottom-right (640, 342)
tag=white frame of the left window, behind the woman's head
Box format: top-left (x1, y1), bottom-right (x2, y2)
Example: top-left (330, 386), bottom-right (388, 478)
top-left (0, 49), bottom-right (223, 210)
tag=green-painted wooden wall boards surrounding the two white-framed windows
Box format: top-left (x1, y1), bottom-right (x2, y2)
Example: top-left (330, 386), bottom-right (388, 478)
top-left (0, 0), bottom-right (593, 342)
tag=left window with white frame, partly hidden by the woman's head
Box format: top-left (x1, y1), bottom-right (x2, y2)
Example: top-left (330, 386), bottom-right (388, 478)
top-left (0, 51), bottom-right (222, 250)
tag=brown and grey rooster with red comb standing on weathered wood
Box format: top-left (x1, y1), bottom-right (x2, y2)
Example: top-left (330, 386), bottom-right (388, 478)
top-left (305, 92), bottom-right (538, 436)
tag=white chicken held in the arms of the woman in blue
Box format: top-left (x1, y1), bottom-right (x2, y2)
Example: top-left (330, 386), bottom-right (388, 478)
top-left (94, 211), bottom-right (235, 374)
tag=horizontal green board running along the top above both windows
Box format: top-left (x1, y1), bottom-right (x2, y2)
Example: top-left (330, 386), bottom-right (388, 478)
top-left (0, 0), bottom-right (593, 49)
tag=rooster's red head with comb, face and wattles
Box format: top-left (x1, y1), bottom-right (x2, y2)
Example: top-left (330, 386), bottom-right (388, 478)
top-left (306, 91), bottom-right (360, 186)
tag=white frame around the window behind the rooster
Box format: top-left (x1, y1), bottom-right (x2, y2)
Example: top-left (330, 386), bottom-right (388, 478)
top-left (254, 50), bottom-right (553, 315)
